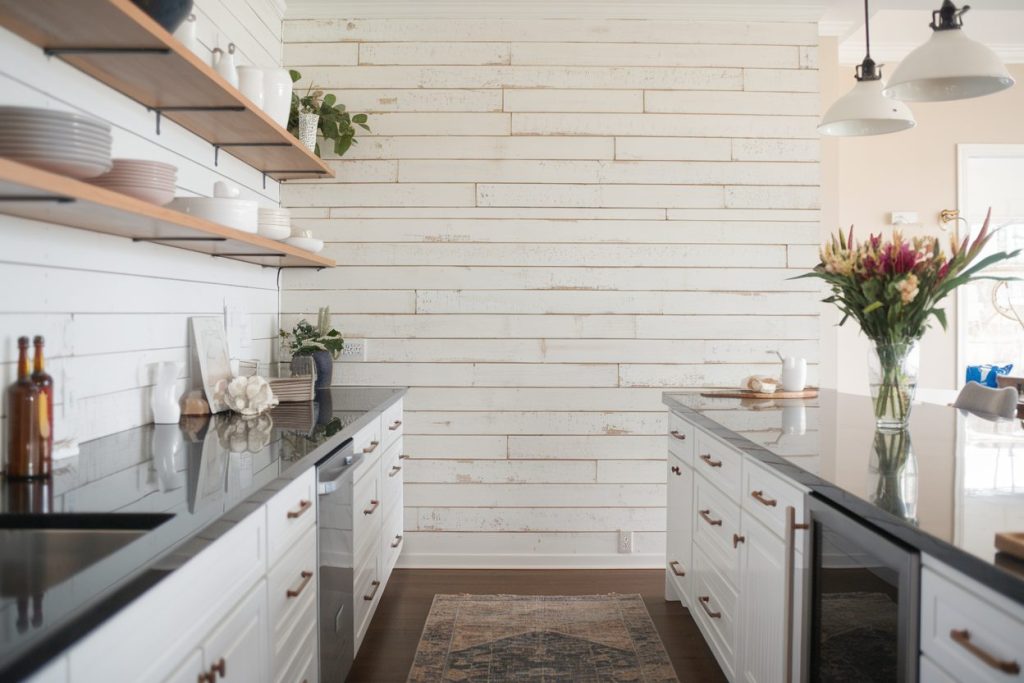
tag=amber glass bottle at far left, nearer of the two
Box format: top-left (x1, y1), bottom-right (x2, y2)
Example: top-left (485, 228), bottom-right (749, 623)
top-left (5, 337), bottom-right (43, 479)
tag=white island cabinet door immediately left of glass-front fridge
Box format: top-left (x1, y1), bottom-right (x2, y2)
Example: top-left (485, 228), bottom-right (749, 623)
top-left (736, 515), bottom-right (786, 683)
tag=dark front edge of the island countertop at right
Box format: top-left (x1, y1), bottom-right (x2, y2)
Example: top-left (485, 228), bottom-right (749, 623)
top-left (662, 392), bottom-right (1024, 605)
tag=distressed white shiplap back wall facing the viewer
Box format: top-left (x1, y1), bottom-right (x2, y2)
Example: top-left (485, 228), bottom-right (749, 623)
top-left (282, 18), bottom-right (819, 566)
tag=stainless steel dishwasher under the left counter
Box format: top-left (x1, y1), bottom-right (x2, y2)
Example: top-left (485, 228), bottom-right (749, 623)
top-left (316, 439), bottom-right (362, 683)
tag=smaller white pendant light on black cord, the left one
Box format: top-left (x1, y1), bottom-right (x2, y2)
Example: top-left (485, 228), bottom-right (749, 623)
top-left (818, 0), bottom-right (916, 137)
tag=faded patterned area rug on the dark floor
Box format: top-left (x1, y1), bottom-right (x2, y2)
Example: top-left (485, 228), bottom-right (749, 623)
top-left (409, 595), bottom-right (679, 683)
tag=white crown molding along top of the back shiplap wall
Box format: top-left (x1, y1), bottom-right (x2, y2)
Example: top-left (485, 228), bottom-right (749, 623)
top-left (285, 0), bottom-right (824, 22)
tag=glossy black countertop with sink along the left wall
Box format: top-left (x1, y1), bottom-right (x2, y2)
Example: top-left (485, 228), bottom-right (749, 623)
top-left (0, 387), bottom-right (406, 681)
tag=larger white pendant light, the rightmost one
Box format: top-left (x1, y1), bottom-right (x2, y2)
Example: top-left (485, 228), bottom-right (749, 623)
top-left (883, 0), bottom-right (1014, 102)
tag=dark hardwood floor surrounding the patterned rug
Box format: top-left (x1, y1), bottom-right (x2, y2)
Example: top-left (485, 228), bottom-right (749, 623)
top-left (352, 569), bottom-right (725, 683)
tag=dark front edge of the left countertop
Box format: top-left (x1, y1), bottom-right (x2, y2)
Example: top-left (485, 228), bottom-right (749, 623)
top-left (0, 387), bottom-right (408, 682)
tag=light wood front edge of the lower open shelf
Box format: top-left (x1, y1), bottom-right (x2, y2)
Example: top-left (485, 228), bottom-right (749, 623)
top-left (0, 158), bottom-right (335, 268)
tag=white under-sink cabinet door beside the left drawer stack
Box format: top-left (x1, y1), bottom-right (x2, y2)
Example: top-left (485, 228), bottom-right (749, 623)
top-left (203, 581), bottom-right (270, 683)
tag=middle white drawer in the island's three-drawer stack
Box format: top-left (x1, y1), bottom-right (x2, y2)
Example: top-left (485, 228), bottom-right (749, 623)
top-left (691, 474), bottom-right (740, 589)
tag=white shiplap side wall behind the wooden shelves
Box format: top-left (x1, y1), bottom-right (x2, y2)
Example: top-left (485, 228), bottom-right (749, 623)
top-left (0, 0), bottom-right (282, 449)
